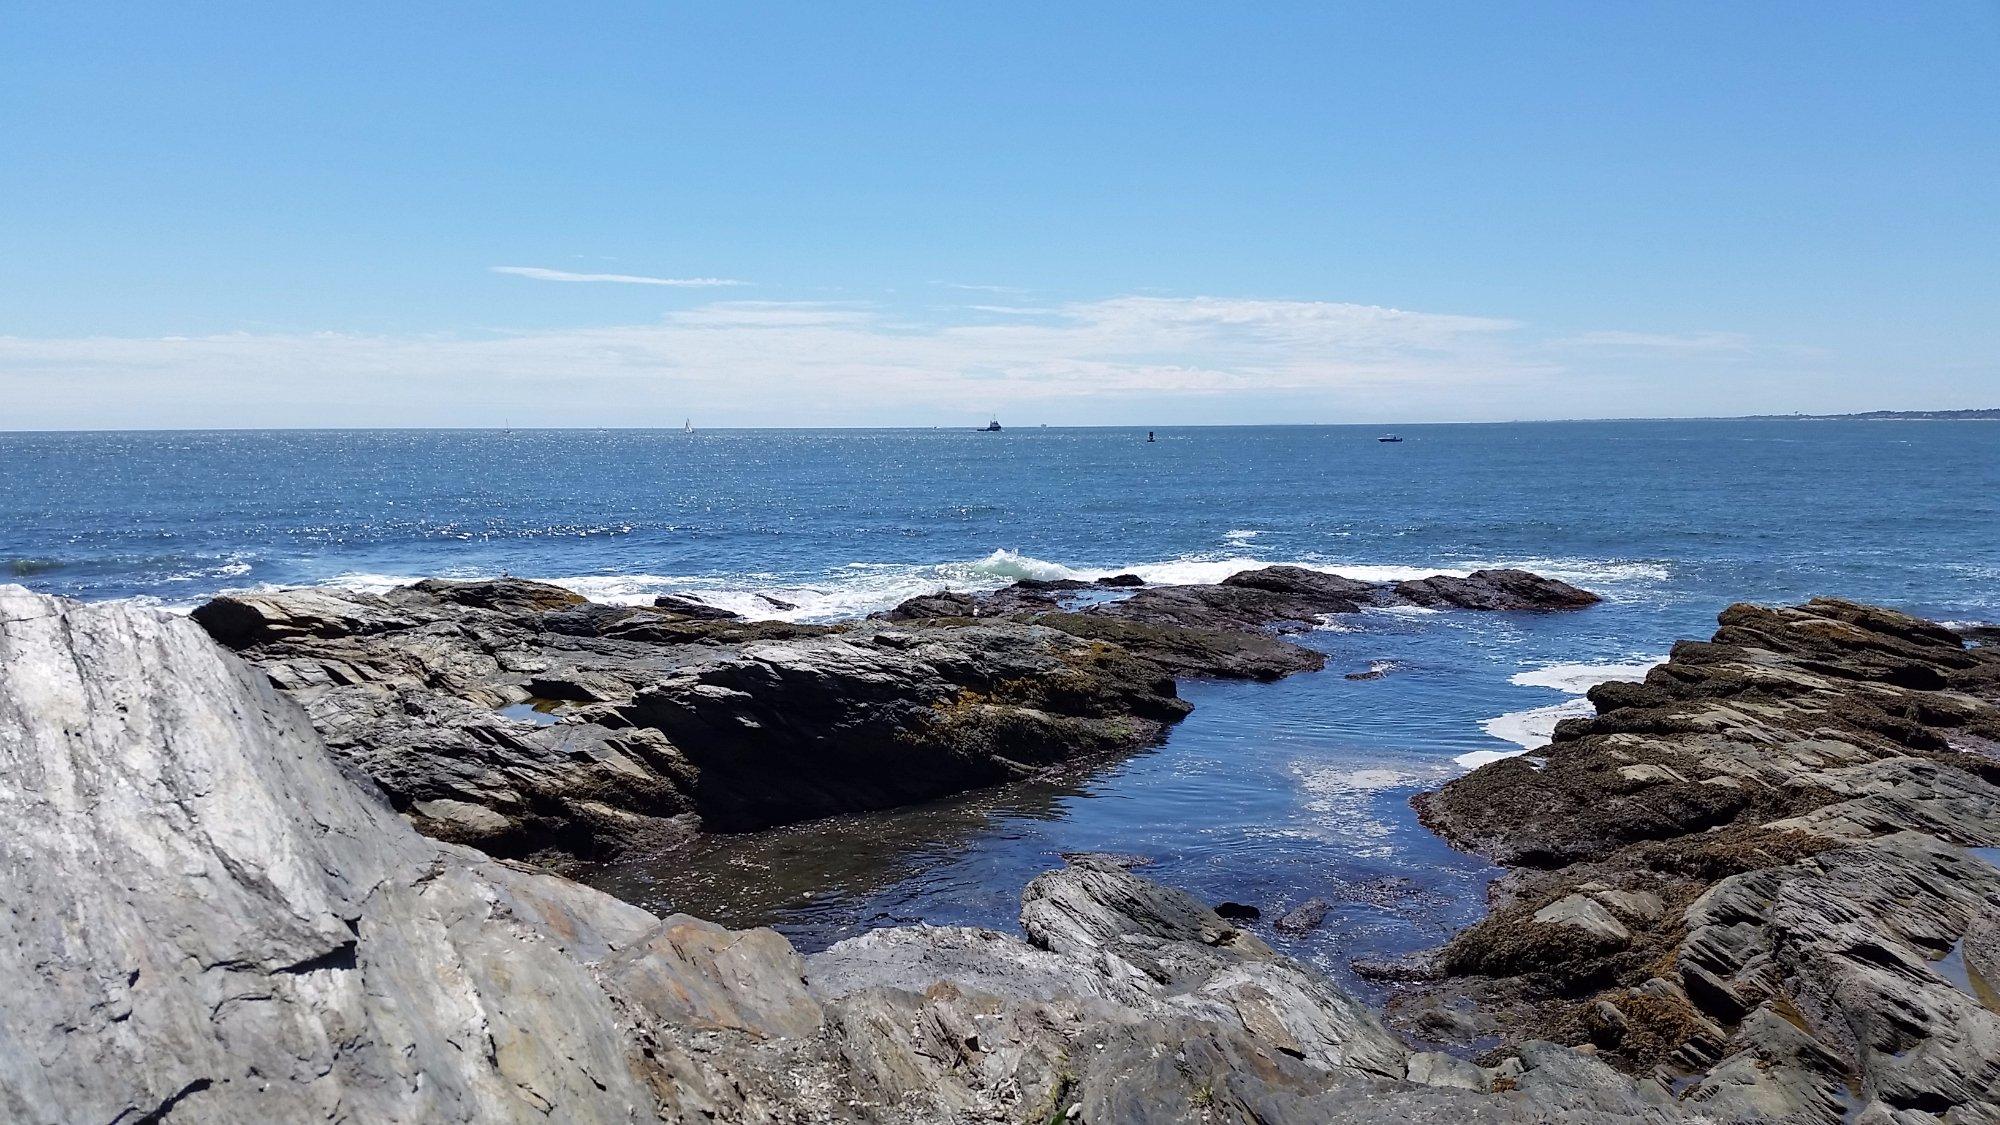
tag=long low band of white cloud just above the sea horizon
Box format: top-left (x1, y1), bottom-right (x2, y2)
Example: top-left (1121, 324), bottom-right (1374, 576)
top-left (0, 296), bottom-right (1816, 426)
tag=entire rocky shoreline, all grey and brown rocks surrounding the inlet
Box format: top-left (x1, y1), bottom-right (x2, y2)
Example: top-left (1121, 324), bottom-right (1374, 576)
top-left (0, 569), bottom-right (2000, 1125)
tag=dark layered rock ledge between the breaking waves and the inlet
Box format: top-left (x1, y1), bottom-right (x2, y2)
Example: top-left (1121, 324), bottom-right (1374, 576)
top-left (194, 567), bottom-right (1594, 871)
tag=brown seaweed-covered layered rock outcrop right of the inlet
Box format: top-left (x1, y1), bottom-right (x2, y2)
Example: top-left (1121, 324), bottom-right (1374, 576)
top-left (1394, 599), bottom-right (2000, 1125)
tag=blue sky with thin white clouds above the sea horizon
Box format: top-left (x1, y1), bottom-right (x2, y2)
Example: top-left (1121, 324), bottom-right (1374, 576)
top-left (0, 0), bottom-right (2000, 430)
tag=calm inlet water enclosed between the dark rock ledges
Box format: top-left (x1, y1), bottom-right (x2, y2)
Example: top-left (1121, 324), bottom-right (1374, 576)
top-left (592, 605), bottom-right (1688, 995)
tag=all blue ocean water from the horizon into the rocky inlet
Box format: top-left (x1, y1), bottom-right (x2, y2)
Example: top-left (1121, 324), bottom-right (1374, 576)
top-left (0, 420), bottom-right (2000, 971)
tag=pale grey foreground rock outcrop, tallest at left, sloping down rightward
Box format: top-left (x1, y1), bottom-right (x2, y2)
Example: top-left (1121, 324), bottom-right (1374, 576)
top-left (0, 587), bottom-right (1706, 1125)
